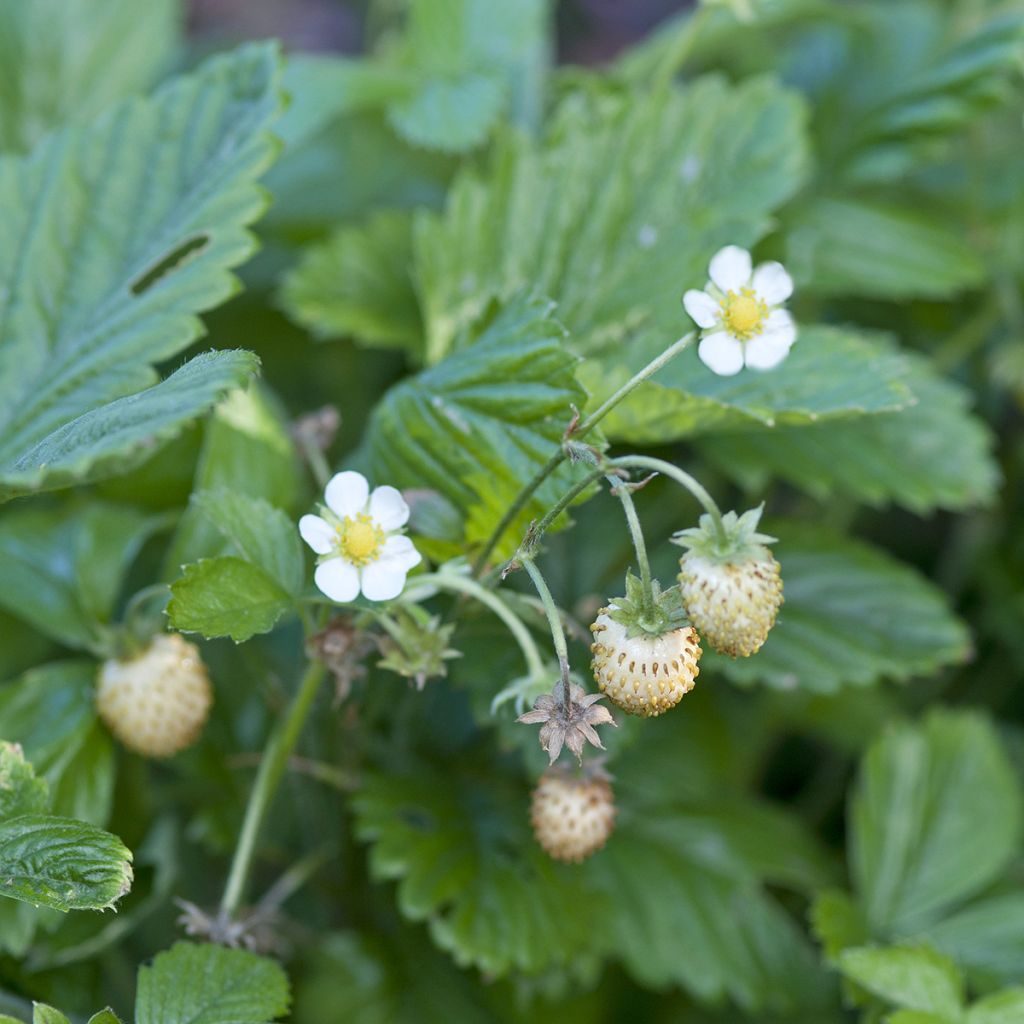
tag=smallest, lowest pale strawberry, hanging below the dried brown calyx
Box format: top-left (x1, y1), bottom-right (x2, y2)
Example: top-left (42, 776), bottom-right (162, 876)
top-left (529, 768), bottom-right (615, 862)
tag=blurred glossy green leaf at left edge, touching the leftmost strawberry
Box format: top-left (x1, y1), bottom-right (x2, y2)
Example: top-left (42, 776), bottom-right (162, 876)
top-left (0, 662), bottom-right (114, 825)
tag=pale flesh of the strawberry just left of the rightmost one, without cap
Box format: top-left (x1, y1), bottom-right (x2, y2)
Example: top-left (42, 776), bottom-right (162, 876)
top-left (590, 604), bottom-right (700, 718)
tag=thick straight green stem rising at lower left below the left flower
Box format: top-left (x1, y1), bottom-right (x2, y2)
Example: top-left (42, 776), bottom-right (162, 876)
top-left (220, 662), bottom-right (327, 919)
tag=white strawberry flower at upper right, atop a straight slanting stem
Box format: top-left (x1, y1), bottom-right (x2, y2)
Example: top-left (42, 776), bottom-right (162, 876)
top-left (683, 246), bottom-right (797, 377)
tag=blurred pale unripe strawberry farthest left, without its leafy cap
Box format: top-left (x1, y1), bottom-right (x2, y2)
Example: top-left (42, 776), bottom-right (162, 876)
top-left (96, 633), bottom-right (213, 758)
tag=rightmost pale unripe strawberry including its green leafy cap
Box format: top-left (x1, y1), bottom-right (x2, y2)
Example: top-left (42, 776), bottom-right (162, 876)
top-left (676, 509), bottom-right (782, 657)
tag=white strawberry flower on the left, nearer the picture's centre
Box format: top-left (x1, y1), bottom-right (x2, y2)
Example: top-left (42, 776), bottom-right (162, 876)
top-left (299, 471), bottom-right (423, 602)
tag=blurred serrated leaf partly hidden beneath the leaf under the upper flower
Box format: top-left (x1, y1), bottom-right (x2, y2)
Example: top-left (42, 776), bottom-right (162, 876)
top-left (699, 353), bottom-right (999, 513)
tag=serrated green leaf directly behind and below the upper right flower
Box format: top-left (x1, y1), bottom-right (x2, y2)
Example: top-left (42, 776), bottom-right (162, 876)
top-left (580, 326), bottom-right (913, 444)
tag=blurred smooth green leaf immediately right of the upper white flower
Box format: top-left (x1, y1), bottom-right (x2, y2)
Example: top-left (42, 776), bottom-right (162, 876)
top-left (785, 197), bottom-right (985, 299)
